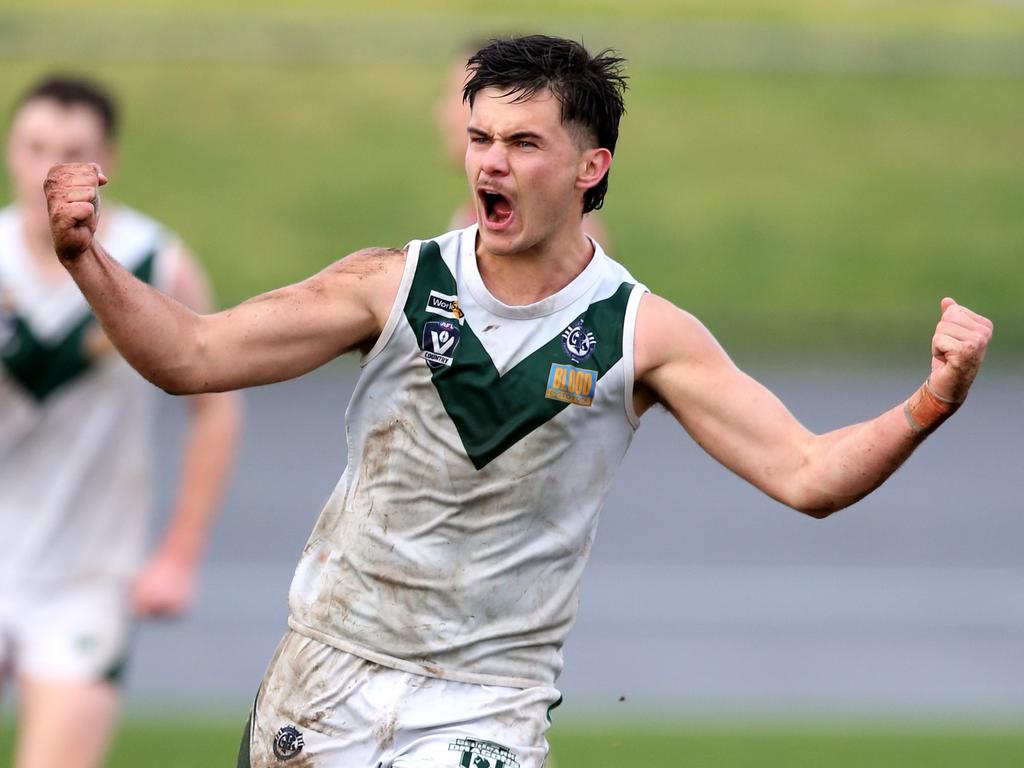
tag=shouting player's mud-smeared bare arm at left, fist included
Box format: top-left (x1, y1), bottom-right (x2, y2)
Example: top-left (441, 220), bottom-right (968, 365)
top-left (45, 163), bottom-right (404, 394)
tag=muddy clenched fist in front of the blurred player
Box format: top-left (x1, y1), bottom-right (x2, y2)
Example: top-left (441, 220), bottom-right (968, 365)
top-left (43, 163), bottom-right (106, 261)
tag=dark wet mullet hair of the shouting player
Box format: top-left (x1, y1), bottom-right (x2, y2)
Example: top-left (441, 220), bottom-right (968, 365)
top-left (463, 35), bottom-right (627, 213)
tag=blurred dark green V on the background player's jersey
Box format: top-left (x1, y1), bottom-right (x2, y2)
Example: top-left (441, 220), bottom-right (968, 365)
top-left (0, 253), bottom-right (156, 402)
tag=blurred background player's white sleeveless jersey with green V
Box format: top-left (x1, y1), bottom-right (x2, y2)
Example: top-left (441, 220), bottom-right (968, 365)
top-left (0, 206), bottom-right (169, 590)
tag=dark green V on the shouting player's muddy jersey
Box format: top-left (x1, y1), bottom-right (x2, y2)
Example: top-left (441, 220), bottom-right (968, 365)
top-left (404, 241), bottom-right (633, 469)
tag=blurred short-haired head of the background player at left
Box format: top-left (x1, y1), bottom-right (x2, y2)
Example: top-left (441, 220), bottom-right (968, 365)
top-left (6, 76), bottom-right (118, 237)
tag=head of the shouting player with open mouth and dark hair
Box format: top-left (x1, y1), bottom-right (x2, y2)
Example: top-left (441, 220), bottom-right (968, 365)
top-left (464, 35), bottom-right (626, 253)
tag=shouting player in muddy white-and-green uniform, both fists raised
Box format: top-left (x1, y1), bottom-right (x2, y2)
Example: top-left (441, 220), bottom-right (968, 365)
top-left (46, 36), bottom-right (991, 768)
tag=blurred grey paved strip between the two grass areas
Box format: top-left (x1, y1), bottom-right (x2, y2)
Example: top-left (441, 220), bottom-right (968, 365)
top-left (129, 368), bottom-right (1024, 718)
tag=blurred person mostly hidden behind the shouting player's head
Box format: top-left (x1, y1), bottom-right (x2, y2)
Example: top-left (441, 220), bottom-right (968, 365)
top-left (434, 40), bottom-right (612, 252)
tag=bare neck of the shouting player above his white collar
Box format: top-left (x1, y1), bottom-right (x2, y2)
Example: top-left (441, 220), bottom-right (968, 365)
top-left (476, 226), bottom-right (594, 306)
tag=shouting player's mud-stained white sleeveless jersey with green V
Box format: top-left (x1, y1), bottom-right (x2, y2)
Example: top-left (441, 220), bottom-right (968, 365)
top-left (290, 224), bottom-right (645, 687)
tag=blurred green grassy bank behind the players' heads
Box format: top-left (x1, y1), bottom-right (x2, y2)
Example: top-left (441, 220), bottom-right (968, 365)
top-left (0, 0), bottom-right (1024, 366)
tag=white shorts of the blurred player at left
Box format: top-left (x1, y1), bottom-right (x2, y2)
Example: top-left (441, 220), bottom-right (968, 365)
top-left (0, 579), bottom-right (132, 683)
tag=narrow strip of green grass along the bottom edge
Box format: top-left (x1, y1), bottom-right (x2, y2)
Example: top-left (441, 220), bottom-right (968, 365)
top-left (6, 722), bottom-right (1024, 768)
